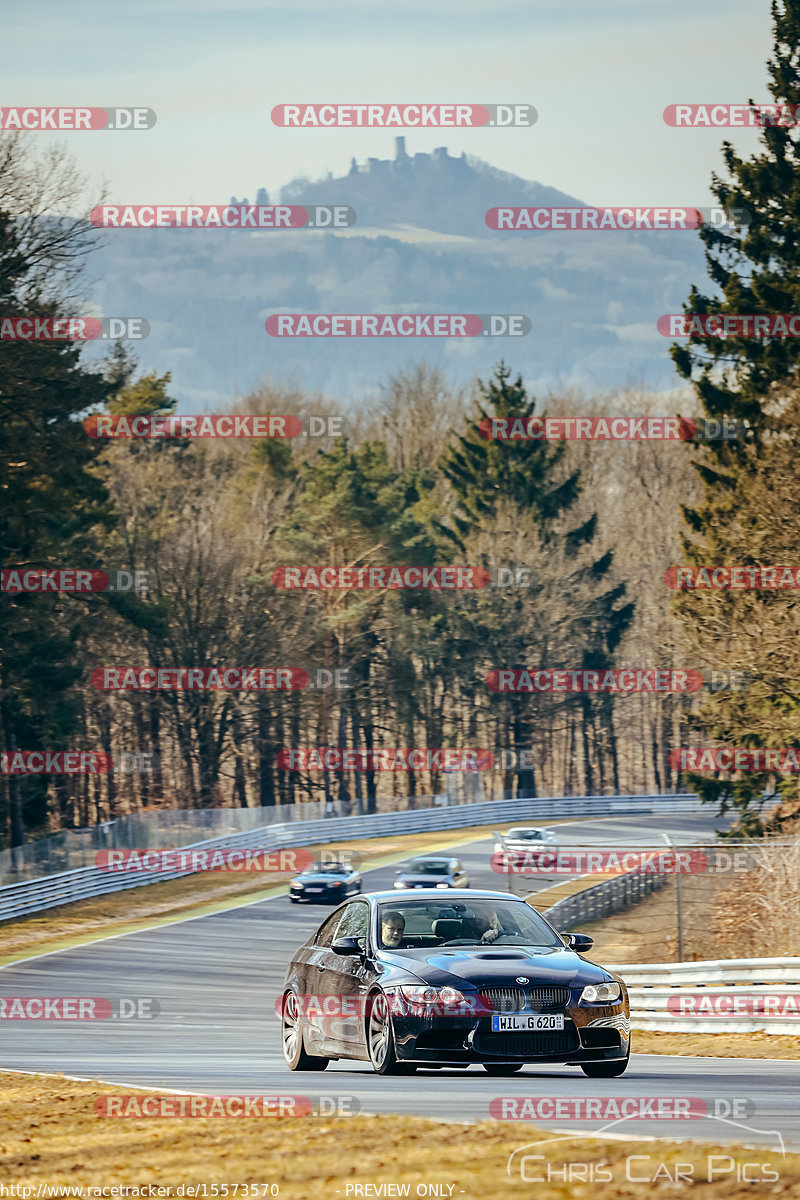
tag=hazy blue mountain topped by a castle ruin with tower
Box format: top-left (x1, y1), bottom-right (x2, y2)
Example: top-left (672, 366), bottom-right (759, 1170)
top-left (89, 138), bottom-right (705, 398)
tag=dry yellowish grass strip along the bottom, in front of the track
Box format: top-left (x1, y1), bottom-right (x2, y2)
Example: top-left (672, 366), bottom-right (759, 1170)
top-left (0, 1073), bottom-right (800, 1200)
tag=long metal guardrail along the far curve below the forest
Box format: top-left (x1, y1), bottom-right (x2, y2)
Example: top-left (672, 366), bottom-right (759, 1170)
top-left (0, 793), bottom-right (705, 920)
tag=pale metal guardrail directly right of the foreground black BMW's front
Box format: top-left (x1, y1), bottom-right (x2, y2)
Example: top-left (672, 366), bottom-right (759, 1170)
top-left (609, 960), bottom-right (800, 1036)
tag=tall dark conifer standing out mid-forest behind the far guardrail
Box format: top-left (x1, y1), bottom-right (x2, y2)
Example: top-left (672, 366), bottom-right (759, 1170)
top-left (441, 364), bottom-right (633, 794)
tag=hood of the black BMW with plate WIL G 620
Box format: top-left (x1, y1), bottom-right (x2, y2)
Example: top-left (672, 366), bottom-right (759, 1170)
top-left (381, 946), bottom-right (615, 990)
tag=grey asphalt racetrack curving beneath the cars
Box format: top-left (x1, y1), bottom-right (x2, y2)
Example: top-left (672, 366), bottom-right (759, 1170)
top-left (0, 816), bottom-right (800, 1150)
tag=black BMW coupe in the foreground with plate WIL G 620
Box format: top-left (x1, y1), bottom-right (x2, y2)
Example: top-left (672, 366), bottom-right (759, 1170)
top-left (279, 889), bottom-right (631, 1079)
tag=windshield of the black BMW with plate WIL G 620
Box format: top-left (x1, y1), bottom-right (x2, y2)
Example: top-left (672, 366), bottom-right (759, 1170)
top-left (378, 899), bottom-right (564, 949)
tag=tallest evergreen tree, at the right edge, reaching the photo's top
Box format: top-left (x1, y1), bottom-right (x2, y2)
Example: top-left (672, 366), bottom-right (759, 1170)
top-left (672, 0), bottom-right (800, 832)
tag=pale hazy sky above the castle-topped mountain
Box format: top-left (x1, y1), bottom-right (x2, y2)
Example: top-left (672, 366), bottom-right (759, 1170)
top-left (0, 0), bottom-right (770, 204)
